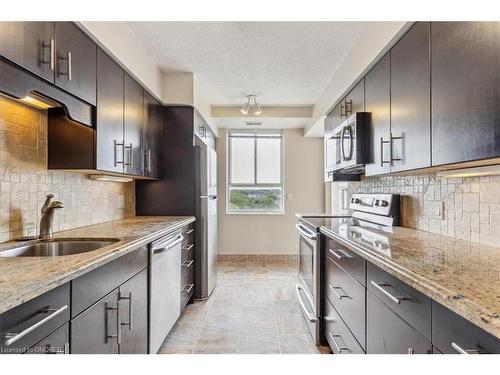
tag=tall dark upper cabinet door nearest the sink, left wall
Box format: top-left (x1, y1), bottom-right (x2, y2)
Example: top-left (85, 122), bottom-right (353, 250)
top-left (96, 49), bottom-right (125, 173)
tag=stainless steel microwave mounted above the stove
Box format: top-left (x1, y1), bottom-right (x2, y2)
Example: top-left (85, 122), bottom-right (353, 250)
top-left (325, 112), bottom-right (371, 176)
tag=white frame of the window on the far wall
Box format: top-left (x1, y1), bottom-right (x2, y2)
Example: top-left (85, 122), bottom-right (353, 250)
top-left (226, 129), bottom-right (285, 215)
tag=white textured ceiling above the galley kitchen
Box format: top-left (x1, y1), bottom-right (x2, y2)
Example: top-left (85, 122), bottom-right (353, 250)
top-left (129, 22), bottom-right (365, 105)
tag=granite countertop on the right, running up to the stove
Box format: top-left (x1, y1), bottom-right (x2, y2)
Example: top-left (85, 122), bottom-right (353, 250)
top-left (321, 220), bottom-right (500, 338)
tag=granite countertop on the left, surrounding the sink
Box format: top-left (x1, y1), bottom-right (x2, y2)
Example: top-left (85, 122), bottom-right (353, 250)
top-left (0, 216), bottom-right (195, 314)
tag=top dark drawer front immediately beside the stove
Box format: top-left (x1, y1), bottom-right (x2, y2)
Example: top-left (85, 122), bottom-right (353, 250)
top-left (325, 237), bottom-right (366, 285)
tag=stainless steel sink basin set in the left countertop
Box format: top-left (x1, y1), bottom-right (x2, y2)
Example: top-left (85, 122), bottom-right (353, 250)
top-left (0, 238), bottom-right (119, 257)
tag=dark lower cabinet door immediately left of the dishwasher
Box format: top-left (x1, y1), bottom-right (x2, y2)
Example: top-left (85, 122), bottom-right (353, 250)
top-left (119, 269), bottom-right (148, 354)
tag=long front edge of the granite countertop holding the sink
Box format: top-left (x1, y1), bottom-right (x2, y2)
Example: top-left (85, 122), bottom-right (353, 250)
top-left (0, 216), bottom-right (196, 314)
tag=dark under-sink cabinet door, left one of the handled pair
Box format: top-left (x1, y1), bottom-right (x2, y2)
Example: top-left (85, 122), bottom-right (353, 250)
top-left (71, 289), bottom-right (121, 354)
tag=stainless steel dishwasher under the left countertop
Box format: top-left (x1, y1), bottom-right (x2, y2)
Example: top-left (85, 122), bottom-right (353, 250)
top-left (149, 231), bottom-right (184, 353)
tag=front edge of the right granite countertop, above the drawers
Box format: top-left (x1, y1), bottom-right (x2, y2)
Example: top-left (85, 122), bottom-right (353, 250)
top-left (320, 227), bottom-right (500, 339)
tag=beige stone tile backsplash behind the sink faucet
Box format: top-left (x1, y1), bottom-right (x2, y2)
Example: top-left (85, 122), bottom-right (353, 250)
top-left (0, 97), bottom-right (135, 242)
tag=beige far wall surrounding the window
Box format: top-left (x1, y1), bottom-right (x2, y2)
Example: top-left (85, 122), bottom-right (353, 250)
top-left (217, 129), bottom-right (325, 254)
